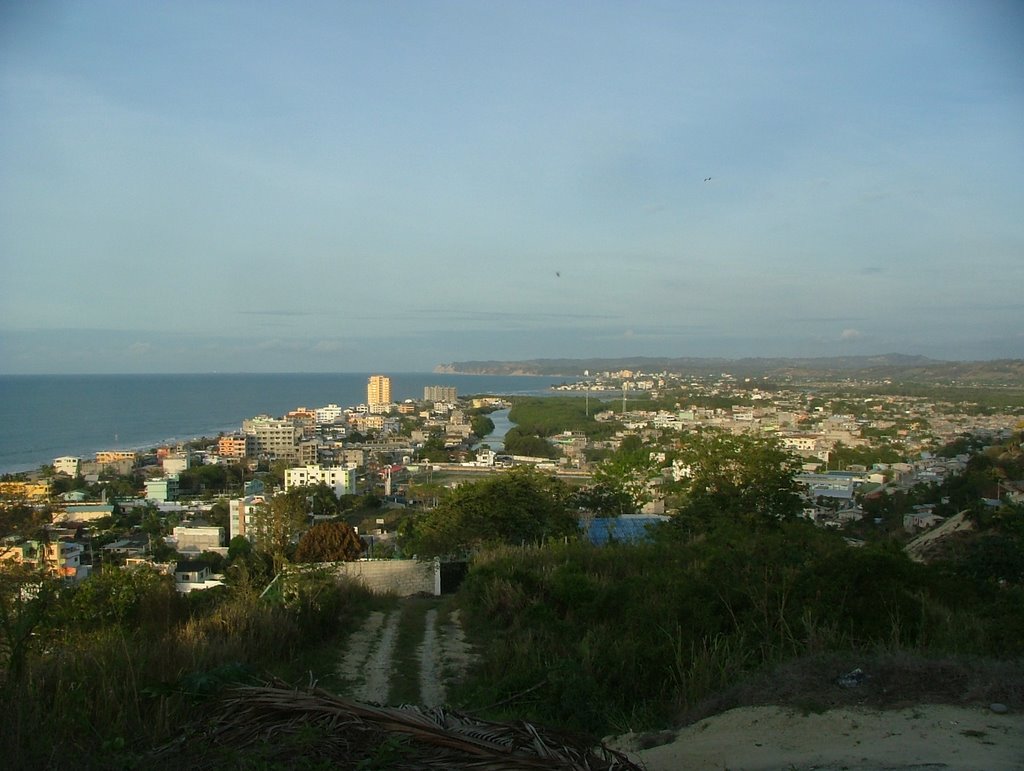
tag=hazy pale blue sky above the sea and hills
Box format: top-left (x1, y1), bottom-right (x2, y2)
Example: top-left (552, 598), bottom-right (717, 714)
top-left (0, 0), bottom-right (1024, 374)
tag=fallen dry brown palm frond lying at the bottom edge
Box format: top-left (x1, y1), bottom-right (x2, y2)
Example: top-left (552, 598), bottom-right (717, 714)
top-left (153, 686), bottom-right (640, 771)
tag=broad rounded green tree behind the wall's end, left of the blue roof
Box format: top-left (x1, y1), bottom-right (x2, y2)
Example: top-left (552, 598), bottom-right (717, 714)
top-left (399, 468), bottom-right (578, 555)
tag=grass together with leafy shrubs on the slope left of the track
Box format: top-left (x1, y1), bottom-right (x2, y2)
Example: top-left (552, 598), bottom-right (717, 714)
top-left (0, 568), bottom-right (370, 768)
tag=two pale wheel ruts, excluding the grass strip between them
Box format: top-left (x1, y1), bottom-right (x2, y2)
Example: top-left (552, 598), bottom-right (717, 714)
top-left (338, 602), bottom-right (474, 706)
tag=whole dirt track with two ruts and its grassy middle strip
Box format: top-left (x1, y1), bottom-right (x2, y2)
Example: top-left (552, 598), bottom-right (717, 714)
top-left (338, 599), bottom-right (473, 706)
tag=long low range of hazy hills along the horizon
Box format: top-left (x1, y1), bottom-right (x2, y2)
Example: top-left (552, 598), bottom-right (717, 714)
top-left (434, 353), bottom-right (1024, 386)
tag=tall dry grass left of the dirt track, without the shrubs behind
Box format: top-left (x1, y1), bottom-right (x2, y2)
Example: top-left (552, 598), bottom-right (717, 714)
top-left (0, 573), bottom-right (380, 768)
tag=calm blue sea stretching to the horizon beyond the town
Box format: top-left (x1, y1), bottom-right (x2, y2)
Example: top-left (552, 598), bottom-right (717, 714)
top-left (0, 373), bottom-right (559, 474)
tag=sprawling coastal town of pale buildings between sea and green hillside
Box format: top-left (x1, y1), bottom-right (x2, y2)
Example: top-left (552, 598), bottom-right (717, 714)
top-left (0, 370), bottom-right (1024, 592)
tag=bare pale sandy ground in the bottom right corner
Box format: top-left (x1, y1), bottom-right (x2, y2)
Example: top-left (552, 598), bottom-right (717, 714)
top-left (608, 704), bottom-right (1024, 771)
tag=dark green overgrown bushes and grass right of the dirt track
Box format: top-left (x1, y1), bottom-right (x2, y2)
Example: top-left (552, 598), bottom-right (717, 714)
top-left (460, 521), bottom-right (1024, 735)
